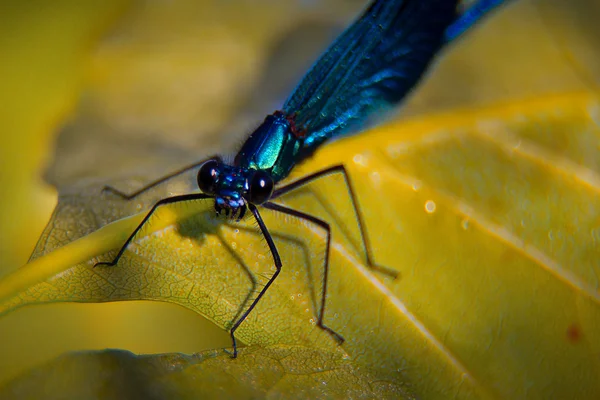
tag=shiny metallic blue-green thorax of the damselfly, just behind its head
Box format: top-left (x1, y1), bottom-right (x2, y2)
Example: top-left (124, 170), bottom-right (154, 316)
top-left (234, 112), bottom-right (304, 183)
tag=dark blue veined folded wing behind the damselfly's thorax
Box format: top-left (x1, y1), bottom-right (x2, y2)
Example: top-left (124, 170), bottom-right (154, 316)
top-left (283, 0), bottom-right (458, 154)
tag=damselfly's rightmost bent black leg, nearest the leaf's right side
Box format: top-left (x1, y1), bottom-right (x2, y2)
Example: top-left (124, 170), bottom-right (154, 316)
top-left (271, 165), bottom-right (398, 279)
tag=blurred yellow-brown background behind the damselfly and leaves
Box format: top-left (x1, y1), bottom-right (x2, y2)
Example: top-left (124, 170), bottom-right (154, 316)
top-left (0, 0), bottom-right (600, 384)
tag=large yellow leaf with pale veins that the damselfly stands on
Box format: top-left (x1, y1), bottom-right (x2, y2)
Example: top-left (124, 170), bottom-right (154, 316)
top-left (0, 93), bottom-right (600, 398)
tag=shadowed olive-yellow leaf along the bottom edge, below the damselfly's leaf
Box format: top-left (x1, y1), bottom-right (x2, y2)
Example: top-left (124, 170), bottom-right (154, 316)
top-left (0, 346), bottom-right (414, 400)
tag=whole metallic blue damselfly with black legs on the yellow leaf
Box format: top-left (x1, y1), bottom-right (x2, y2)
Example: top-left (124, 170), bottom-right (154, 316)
top-left (96, 0), bottom-right (508, 357)
